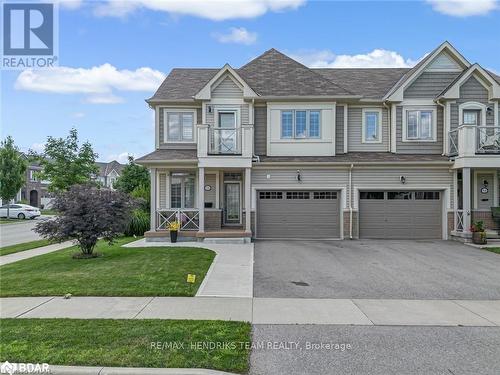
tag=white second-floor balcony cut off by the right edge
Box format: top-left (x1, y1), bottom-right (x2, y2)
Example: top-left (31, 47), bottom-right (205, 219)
top-left (448, 125), bottom-right (500, 157)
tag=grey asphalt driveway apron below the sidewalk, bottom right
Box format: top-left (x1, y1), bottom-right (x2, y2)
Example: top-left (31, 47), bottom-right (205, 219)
top-left (250, 325), bottom-right (500, 375)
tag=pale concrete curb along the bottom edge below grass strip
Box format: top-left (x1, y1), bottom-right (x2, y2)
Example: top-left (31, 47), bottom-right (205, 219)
top-left (49, 366), bottom-right (235, 375)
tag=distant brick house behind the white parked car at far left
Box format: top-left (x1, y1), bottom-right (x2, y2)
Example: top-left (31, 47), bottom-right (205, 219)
top-left (17, 161), bottom-right (53, 208)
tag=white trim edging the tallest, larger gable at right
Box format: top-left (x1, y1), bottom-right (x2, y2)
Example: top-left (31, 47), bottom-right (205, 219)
top-left (384, 42), bottom-right (470, 102)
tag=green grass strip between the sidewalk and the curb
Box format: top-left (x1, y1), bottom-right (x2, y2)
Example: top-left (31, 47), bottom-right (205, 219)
top-left (0, 319), bottom-right (250, 373)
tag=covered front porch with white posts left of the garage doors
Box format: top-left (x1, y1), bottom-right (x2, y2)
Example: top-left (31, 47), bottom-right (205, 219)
top-left (145, 165), bottom-right (252, 242)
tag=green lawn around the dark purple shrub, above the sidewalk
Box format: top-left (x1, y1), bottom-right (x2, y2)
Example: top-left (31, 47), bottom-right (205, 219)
top-left (0, 237), bottom-right (215, 297)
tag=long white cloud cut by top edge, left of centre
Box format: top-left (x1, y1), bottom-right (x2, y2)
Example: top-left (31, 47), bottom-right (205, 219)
top-left (94, 0), bottom-right (306, 21)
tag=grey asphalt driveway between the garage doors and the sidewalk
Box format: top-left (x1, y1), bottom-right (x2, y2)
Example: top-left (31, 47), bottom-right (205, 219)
top-left (254, 240), bottom-right (500, 300)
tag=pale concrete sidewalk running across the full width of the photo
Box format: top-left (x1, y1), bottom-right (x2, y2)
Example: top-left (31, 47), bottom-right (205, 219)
top-left (0, 297), bottom-right (500, 327)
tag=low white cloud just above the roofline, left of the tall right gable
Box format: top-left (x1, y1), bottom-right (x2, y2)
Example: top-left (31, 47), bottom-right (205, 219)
top-left (291, 49), bottom-right (417, 68)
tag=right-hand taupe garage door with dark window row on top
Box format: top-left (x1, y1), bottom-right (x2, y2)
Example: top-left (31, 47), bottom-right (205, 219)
top-left (359, 191), bottom-right (443, 239)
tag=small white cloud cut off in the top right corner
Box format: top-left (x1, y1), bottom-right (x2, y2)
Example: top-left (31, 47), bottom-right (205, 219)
top-left (427, 0), bottom-right (499, 17)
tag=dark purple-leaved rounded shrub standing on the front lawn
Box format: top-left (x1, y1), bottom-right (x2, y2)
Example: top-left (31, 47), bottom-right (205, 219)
top-left (35, 184), bottom-right (133, 257)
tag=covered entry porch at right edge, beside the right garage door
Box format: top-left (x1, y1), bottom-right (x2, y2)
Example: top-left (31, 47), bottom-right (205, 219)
top-left (452, 167), bottom-right (500, 239)
